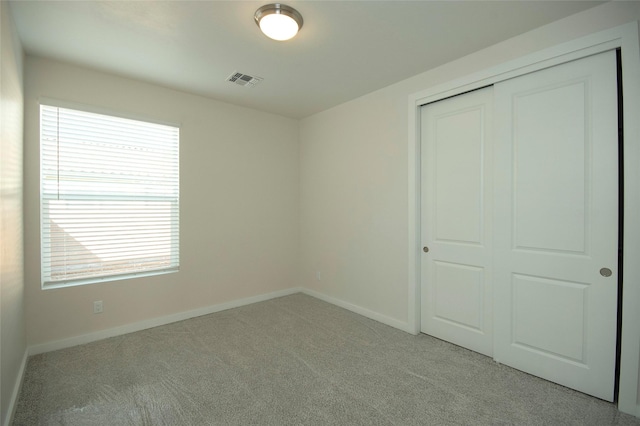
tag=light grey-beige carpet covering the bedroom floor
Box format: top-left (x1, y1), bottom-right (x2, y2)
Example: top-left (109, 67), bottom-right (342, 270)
top-left (14, 294), bottom-right (640, 426)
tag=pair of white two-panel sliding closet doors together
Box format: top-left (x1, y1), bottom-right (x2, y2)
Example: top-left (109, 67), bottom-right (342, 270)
top-left (420, 51), bottom-right (619, 401)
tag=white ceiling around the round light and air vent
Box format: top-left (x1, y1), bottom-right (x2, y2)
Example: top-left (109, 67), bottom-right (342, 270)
top-left (11, 0), bottom-right (602, 118)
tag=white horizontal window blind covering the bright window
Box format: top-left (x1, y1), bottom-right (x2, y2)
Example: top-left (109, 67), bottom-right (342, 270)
top-left (40, 105), bottom-right (179, 287)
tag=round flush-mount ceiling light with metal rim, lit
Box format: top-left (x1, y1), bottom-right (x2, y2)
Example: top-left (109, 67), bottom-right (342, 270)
top-left (253, 3), bottom-right (302, 41)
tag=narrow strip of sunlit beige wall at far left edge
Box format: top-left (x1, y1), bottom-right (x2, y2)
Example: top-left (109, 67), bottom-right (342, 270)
top-left (0, 2), bottom-right (26, 424)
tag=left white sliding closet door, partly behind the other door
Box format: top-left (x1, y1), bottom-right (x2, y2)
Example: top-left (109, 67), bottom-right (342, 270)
top-left (421, 87), bottom-right (493, 355)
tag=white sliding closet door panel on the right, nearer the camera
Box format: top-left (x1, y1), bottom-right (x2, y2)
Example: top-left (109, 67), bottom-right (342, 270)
top-left (494, 52), bottom-right (618, 401)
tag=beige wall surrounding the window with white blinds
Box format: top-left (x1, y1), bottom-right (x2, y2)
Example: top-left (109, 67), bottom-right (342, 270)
top-left (25, 57), bottom-right (299, 345)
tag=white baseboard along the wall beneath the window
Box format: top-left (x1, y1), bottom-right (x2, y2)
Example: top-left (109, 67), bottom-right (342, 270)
top-left (28, 288), bottom-right (301, 355)
